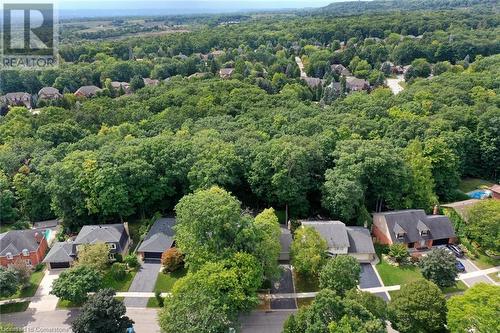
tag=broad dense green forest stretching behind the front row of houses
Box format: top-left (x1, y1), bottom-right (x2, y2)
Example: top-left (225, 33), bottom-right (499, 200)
top-left (0, 2), bottom-right (500, 230)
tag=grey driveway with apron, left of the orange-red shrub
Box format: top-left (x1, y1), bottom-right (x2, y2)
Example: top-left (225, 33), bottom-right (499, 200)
top-left (124, 263), bottom-right (161, 308)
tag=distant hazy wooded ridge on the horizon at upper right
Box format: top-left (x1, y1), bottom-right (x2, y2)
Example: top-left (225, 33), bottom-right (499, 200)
top-left (313, 0), bottom-right (497, 16)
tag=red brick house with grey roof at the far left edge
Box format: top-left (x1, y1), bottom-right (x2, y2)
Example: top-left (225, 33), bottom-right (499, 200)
top-left (0, 229), bottom-right (48, 267)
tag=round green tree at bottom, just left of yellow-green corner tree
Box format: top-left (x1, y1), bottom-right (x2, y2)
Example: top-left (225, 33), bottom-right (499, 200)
top-left (389, 280), bottom-right (446, 333)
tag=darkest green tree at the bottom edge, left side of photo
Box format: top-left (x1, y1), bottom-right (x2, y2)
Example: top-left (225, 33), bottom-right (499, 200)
top-left (71, 289), bottom-right (134, 333)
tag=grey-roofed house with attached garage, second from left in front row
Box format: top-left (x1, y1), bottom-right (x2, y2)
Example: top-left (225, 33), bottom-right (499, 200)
top-left (44, 223), bottom-right (130, 269)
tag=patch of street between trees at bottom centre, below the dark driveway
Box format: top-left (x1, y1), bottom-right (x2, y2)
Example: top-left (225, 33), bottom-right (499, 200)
top-left (240, 310), bottom-right (295, 333)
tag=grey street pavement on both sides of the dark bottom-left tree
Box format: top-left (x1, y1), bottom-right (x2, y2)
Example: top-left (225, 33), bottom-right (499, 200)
top-left (1, 309), bottom-right (160, 333)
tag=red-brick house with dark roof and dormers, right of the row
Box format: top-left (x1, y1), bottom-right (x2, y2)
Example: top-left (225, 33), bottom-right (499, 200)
top-left (372, 209), bottom-right (456, 250)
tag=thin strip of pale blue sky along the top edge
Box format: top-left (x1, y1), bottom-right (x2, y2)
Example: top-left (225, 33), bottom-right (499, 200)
top-left (58, 0), bottom-right (338, 18)
